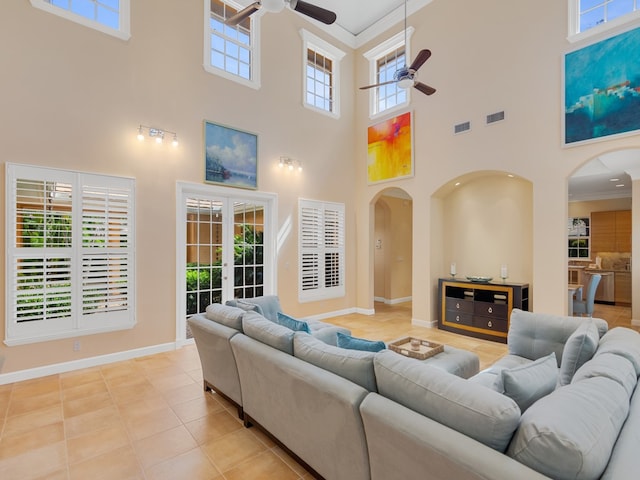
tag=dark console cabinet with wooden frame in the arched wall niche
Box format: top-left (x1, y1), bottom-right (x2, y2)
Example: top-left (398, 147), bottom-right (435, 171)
top-left (438, 278), bottom-right (529, 343)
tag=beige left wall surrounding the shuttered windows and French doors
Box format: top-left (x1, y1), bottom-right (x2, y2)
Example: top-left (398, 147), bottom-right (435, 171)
top-left (0, 0), bottom-right (357, 373)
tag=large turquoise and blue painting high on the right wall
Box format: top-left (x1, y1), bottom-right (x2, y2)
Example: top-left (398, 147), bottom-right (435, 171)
top-left (564, 28), bottom-right (640, 145)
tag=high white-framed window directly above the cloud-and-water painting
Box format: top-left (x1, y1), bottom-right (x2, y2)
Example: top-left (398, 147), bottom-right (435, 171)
top-left (204, 0), bottom-right (260, 88)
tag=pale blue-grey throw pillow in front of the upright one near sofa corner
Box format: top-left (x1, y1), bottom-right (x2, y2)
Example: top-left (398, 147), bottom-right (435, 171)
top-left (495, 352), bottom-right (558, 413)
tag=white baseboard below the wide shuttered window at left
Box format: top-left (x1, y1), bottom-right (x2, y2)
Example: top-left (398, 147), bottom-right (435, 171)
top-left (0, 341), bottom-right (178, 385)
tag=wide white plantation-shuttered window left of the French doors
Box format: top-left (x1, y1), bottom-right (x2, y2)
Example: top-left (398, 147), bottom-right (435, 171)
top-left (5, 164), bottom-right (135, 345)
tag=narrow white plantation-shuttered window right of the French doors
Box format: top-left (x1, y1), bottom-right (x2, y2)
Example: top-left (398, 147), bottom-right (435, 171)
top-left (298, 199), bottom-right (345, 302)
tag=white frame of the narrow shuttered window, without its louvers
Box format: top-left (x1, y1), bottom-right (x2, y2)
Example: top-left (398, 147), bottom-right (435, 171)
top-left (298, 198), bottom-right (346, 303)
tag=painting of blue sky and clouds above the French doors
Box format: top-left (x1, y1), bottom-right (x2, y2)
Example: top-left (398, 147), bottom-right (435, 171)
top-left (204, 120), bottom-right (258, 190)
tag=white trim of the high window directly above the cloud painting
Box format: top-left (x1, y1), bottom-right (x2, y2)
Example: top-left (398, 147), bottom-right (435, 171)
top-left (202, 0), bottom-right (258, 90)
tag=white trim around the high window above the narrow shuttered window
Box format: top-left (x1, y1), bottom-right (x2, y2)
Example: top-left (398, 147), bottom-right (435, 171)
top-left (300, 28), bottom-right (345, 118)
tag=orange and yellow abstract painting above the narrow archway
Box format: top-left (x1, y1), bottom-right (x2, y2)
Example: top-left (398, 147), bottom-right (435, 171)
top-left (367, 112), bottom-right (413, 183)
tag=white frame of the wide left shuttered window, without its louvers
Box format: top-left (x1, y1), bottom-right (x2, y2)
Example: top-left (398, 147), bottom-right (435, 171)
top-left (4, 163), bottom-right (136, 346)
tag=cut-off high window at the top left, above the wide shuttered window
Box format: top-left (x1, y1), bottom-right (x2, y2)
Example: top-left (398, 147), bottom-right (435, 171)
top-left (31, 0), bottom-right (131, 40)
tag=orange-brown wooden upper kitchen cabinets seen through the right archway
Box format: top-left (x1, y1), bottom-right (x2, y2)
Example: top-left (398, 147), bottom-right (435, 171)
top-left (591, 210), bottom-right (631, 258)
